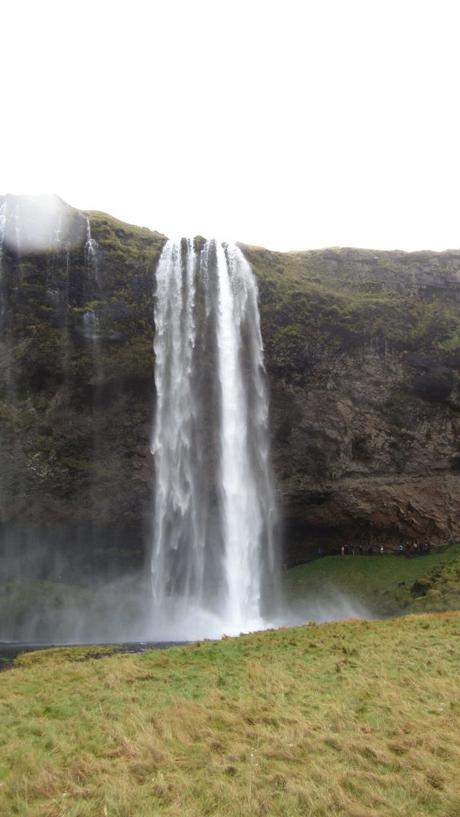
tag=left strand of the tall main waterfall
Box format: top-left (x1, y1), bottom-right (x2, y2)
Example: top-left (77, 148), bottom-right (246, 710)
top-left (152, 236), bottom-right (205, 609)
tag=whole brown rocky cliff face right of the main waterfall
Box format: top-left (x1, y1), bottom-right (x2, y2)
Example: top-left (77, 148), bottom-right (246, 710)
top-left (246, 242), bottom-right (460, 561)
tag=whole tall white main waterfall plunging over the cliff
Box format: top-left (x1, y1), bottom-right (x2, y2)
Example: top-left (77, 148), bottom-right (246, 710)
top-left (151, 239), bottom-right (277, 638)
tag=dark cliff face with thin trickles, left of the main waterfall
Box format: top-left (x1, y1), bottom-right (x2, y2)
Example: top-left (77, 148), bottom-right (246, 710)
top-left (0, 197), bottom-right (165, 579)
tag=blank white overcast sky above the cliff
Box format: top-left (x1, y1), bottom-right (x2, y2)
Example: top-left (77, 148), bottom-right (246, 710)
top-left (0, 0), bottom-right (460, 249)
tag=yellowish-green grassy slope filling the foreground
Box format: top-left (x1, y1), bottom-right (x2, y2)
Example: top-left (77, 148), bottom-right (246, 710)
top-left (0, 614), bottom-right (460, 817)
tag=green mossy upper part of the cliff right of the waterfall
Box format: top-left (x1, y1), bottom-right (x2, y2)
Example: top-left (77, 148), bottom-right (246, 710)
top-left (243, 241), bottom-right (460, 368)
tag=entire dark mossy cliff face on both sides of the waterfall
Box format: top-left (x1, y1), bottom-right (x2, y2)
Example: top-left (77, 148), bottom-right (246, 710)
top-left (0, 196), bottom-right (460, 577)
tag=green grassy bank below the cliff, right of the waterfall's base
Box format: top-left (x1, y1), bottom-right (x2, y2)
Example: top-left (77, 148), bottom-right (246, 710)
top-left (285, 545), bottom-right (460, 615)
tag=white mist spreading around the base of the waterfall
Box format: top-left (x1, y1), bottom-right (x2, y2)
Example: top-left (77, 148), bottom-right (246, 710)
top-left (0, 560), bottom-right (375, 645)
